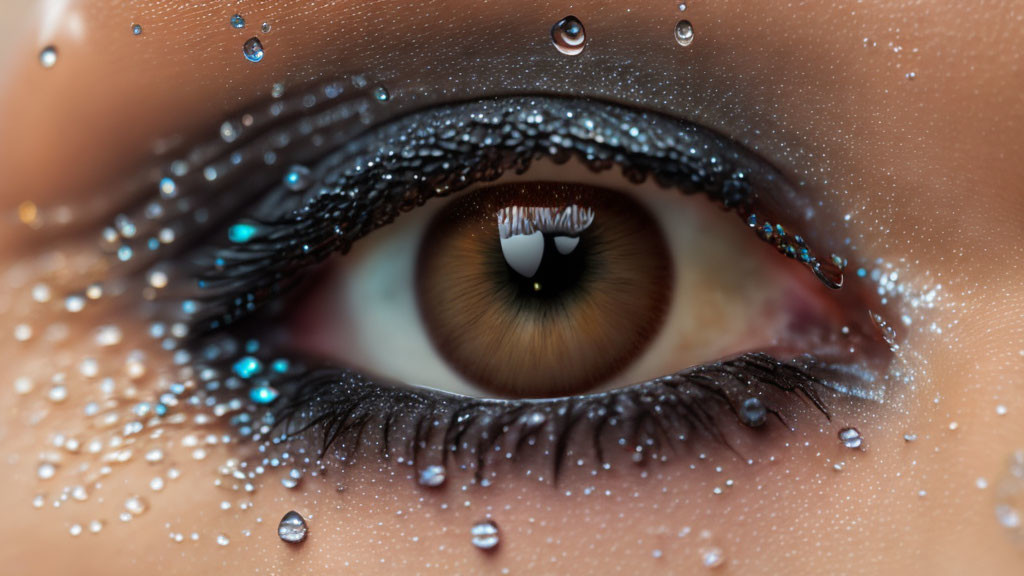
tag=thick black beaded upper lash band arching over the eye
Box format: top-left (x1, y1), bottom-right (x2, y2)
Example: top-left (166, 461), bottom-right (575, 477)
top-left (182, 97), bottom-right (845, 329)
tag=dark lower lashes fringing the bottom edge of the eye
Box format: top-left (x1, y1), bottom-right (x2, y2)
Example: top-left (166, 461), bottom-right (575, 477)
top-left (207, 354), bottom-right (864, 480)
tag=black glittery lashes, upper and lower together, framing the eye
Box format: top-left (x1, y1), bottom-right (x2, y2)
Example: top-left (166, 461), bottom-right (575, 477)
top-left (92, 84), bottom-right (884, 479)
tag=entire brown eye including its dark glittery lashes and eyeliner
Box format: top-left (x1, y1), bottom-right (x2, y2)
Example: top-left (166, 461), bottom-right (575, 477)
top-left (132, 87), bottom-right (888, 477)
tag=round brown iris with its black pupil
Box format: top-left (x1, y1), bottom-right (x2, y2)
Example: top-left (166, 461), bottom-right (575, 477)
top-left (417, 182), bottom-right (673, 398)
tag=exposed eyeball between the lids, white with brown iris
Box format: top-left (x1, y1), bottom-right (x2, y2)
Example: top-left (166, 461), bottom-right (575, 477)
top-left (292, 172), bottom-right (835, 398)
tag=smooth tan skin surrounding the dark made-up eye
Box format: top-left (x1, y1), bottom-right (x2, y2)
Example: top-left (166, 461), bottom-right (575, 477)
top-left (0, 0), bottom-right (1024, 574)
